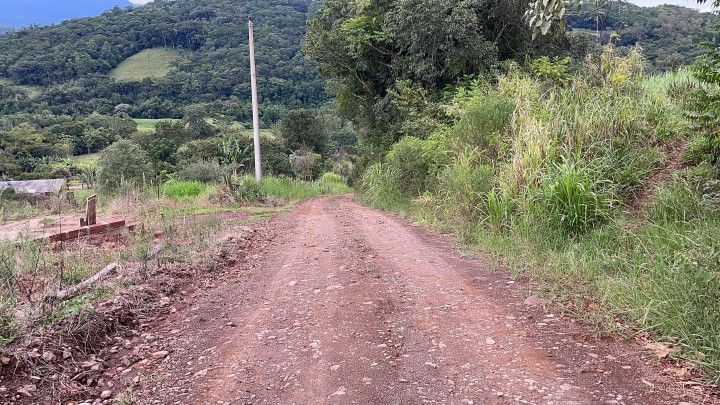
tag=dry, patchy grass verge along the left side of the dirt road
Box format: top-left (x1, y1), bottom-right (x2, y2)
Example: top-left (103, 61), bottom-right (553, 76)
top-left (0, 174), bottom-right (350, 344)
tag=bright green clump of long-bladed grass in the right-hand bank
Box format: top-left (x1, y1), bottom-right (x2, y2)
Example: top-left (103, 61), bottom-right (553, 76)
top-left (539, 160), bottom-right (614, 235)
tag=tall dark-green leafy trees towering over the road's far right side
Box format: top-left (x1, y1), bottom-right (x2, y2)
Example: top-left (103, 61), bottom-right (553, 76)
top-left (305, 0), bottom-right (582, 159)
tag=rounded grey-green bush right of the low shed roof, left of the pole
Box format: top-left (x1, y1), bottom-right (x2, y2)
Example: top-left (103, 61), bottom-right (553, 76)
top-left (98, 140), bottom-right (151, 190)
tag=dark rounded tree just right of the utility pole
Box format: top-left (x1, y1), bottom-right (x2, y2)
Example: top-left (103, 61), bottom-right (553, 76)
top-left (278, 109), bottom-right (327, 153)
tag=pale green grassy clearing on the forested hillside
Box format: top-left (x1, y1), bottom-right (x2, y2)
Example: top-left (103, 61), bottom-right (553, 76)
top-left (110, 48), bottom-right (183, 82)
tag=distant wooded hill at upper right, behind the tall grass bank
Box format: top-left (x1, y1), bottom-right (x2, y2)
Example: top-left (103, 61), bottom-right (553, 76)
top-left (568, 1), bottom-right (718, 70)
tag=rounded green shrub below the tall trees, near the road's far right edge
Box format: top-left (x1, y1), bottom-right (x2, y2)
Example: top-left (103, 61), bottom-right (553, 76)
top-left (386, 136), bottom-right (431, 197)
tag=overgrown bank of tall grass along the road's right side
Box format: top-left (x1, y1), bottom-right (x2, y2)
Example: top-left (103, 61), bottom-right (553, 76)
top-left (359, 49), bottom-right (720, 382)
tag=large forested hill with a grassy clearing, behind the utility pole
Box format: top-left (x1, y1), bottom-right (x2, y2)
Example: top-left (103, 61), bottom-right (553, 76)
top-left (0, 0), bottom-right (327, 123)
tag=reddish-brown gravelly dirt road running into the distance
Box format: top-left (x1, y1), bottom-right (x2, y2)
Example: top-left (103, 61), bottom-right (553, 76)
top-left (135, 197), bottom-right (696, 404)
